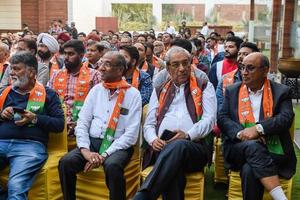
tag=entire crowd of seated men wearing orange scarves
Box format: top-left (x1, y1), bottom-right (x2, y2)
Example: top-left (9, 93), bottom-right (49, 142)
top-left (0, 21), bottom-right (297, 200)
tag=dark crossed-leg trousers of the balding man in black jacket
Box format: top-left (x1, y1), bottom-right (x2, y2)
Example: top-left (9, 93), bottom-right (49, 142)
top-left (225, 140), bottom-right (278, 200)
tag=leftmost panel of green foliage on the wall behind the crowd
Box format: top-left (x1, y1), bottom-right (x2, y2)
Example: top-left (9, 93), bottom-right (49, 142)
top-left (112, 4), bottom-right (156, 31)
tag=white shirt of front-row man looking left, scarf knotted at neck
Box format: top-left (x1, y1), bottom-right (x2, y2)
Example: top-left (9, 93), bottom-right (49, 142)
top-left (75, 83), bottom-right (142, 155)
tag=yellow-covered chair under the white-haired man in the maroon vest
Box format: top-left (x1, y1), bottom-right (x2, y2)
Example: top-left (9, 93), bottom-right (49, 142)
top-left (141, 166), bottom-right (204, 200)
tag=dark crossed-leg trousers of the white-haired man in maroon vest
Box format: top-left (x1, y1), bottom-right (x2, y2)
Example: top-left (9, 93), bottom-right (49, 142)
top-left (133, 140), bottom-right (208, 200)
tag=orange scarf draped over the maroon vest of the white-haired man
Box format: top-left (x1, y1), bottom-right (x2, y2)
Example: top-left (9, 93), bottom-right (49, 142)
top-left (157, 68), bottom-right (203, 121)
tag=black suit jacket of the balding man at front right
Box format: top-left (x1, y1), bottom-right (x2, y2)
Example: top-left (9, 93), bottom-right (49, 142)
top-left (218, 81), bottom-right (297, 178)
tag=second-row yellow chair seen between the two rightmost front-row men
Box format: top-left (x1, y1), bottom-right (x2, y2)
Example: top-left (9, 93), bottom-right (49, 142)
top-left (214, 138), bottom-right (228, 184)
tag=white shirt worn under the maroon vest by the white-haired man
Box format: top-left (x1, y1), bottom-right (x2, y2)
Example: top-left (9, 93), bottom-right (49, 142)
top-left (144, 82), bottom-right (217, 144)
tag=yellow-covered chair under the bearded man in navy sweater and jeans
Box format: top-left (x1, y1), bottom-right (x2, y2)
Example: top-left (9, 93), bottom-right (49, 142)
top-left (0, 118), bottom-right (68, 200)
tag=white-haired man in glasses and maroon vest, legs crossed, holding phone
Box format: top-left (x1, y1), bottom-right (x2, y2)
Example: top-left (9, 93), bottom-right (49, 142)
top-left (133, 47), bottom-right (217, 200)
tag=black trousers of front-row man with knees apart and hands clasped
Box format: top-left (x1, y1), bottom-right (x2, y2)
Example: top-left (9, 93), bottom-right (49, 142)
top-left (58, 138), bottom-right (133, 200)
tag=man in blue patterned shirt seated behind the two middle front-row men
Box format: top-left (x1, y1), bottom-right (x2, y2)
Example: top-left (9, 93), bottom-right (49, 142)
top-left (120, 45), bottom-right (153, 106)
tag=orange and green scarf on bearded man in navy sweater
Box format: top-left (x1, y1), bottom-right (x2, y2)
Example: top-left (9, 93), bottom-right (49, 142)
top-left (0, 81), bottom-right (46, 113)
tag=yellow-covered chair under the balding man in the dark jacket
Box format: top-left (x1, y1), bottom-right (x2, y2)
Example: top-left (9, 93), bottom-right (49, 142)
top-left (228, 118), bottom-right (295, 200)
